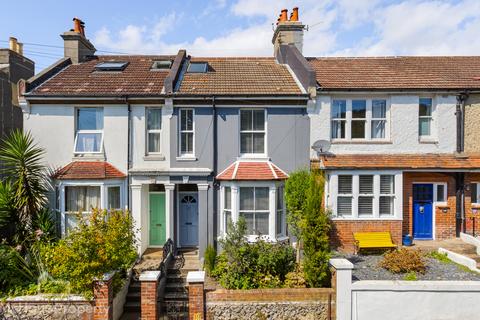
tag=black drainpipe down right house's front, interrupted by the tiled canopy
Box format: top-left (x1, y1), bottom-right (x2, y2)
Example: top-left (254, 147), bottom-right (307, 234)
top-left (455, 91), bottom-right (468, 237)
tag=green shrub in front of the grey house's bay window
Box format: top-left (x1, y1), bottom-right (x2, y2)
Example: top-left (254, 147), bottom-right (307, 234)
top-left (211, 218), bottom-right (295, 289)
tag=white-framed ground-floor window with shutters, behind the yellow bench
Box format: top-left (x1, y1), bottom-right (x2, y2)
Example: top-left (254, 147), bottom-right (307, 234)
top-left (328, 172), bottom-right (401, 219)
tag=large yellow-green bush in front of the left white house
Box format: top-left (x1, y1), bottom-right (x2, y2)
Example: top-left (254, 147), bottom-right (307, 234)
top-left (41, 210), bottom-right (137, 297)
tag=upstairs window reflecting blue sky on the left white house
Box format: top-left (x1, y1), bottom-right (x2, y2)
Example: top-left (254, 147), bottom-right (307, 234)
top-left (74, 108), bottom-right (103, 154)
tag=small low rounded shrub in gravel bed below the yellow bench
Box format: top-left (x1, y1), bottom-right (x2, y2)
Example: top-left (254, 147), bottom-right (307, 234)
top-left (379, 248), bottom-right (426, 274)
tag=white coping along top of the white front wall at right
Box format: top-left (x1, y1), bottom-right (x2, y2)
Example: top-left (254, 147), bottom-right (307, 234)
top-left (352, 280), bottom-right (480, 292)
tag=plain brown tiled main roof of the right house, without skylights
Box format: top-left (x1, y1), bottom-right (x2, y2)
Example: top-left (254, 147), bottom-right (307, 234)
top-left (307, 56), bottom-right (480, 90)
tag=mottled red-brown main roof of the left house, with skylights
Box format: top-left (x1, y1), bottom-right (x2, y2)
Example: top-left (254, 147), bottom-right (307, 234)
top-left (32, 55), bottom-right (175, 96)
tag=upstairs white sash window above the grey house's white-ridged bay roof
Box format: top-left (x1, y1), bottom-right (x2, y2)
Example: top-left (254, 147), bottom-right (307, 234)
top-left (240, 109), bottom-right (266, 154)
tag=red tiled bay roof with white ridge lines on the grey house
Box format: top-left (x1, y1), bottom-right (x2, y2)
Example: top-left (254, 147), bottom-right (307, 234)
top-left (217, 161), bottom-right (288, 181)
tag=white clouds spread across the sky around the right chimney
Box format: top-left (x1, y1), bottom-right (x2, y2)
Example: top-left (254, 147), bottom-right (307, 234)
top-left (94, 0), bottom-right (480, 56)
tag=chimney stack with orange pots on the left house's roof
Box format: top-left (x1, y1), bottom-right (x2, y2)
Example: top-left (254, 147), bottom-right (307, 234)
top-left (61, 18), bottom-right (97, 64)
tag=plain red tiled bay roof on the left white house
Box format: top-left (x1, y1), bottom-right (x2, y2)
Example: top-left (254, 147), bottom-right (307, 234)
top-left (55, 161), bottom-right (126, 180)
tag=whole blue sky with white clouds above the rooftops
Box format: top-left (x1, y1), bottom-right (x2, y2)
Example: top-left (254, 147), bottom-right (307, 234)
top-left (0, 0), bottom-right (480, 70)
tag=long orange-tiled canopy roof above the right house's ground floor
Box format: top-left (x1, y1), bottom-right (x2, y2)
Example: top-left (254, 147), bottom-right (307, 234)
top-left (312, 153), bottom-right (480, 170)
